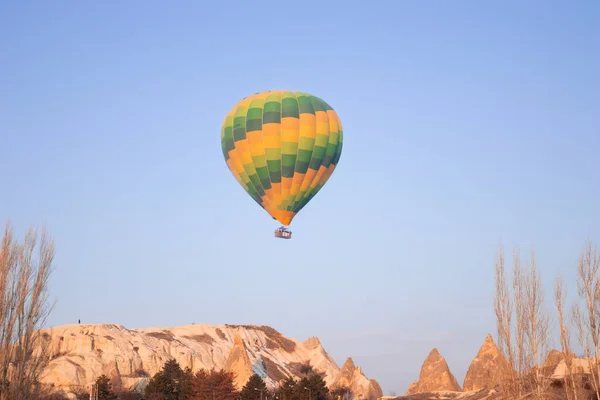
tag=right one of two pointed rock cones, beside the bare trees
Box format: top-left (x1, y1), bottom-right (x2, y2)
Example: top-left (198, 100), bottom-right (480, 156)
top-left (463, 335), bottom-right (510, 391)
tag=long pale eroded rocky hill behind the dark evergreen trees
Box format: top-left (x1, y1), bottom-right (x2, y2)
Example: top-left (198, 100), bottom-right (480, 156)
top-left (37, 324), bottom-right (382, 399)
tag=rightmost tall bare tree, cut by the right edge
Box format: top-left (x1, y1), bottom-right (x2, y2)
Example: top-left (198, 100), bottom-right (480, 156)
top-left (573, 239), bottom-right (600, 400)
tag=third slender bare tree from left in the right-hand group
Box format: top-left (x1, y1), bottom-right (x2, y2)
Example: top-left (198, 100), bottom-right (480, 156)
top-left (524, 250), bottom-right (550, 398)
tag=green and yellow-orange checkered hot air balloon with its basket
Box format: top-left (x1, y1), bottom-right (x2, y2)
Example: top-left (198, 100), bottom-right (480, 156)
top-left (221, 90), bottom-right (343, 239)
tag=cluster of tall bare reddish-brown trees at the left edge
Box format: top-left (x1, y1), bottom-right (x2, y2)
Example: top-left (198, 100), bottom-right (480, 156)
top-left (0, 223), bottom-right (54, 400)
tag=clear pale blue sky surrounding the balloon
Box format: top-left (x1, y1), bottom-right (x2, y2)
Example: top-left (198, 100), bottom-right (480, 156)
top-left (0, 0), bottom-right (600, 394)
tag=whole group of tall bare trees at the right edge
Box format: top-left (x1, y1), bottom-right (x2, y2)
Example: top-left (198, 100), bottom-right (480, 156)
top-left (494, 239), bottom-right (600, 400)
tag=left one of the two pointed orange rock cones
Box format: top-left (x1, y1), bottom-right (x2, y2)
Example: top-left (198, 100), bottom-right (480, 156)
top-left (406, 348), bottom-right (461, 396)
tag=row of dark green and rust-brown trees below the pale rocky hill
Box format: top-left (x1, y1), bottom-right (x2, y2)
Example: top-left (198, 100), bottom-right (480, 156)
top-left (61, 360), bottom-right (354, 400)
